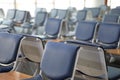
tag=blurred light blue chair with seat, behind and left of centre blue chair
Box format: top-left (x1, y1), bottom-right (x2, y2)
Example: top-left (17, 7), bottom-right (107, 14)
top-left (22, 12), bottom-right (48, 34)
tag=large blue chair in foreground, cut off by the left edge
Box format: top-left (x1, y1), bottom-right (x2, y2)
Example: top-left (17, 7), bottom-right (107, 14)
top-left (0, 33), bottom-right (23, 72)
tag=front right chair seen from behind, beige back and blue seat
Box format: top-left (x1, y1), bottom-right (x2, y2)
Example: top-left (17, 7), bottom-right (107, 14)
top-left (76, 45), bottom-right (120, 80)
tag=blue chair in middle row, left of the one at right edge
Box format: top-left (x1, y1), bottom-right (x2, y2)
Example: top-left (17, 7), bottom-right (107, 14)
top-left (67, 21), bottom-right (98, 44)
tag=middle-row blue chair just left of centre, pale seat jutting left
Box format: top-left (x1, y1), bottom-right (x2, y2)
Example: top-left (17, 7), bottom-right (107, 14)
top-left (36, 18), bottom-right (62, 40)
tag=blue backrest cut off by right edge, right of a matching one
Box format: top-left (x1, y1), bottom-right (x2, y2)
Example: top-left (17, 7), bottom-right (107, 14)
top-left (97, 23), bottom-right (120, 44)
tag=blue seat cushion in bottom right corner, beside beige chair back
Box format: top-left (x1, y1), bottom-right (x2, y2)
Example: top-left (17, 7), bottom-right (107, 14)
top-left (108, 66), bottom-right (120, 80)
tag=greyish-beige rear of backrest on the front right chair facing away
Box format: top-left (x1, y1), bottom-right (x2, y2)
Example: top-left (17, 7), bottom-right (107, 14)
top-left (76, 46), bottom-right (108, 80)
